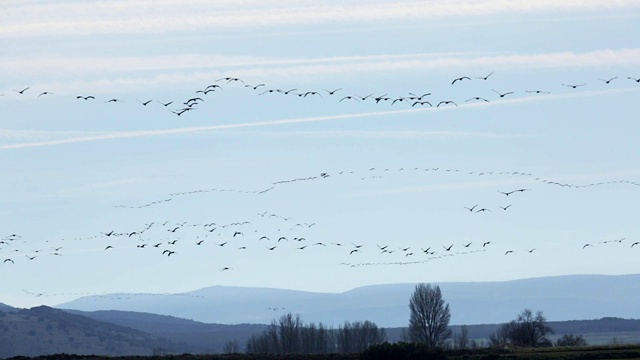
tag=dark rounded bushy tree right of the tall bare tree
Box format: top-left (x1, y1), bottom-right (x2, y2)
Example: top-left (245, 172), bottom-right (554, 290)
top-left (489, 309), bottom-right (553, 347)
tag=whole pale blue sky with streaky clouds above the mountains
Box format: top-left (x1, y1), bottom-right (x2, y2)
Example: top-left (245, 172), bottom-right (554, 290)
top-left (0, 0), bottom-right (640, 307)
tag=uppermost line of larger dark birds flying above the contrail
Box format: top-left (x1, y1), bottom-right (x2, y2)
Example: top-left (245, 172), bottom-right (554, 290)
top-left (0, 72), bottom-right (640, 116)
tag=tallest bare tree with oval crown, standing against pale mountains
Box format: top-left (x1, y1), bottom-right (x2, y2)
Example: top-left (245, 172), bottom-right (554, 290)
top-left (409, 284), bottom-right (451, 348)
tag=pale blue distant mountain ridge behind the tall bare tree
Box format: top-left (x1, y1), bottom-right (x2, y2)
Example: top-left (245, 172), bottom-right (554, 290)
top-left (57, 274), bottom-right (640, 327)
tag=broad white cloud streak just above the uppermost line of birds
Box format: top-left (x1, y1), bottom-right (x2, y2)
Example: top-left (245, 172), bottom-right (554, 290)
top-left (0, 48), bottom-right (640, 95)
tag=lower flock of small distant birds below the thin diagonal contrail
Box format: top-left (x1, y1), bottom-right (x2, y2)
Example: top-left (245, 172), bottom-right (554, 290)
top-left (0, 162), bottom-right (640, 272)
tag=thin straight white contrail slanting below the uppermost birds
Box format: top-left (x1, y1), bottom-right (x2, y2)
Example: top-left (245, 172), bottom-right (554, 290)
top-left (0, 88), bottom-right (640, 150)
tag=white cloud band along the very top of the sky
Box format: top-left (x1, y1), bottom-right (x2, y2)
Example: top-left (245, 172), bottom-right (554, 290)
top-left (0, 0), bottom-right (638, 37)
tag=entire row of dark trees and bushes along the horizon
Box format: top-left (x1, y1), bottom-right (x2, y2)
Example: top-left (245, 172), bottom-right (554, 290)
top-left (235, 284), bottom-right (587, 354)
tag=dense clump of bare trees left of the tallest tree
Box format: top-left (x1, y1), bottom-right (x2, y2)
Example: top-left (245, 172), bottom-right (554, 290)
top-left (246, 313), bottom-right (387, 354)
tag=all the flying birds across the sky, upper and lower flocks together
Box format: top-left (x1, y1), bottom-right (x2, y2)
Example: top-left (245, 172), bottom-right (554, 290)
top-left (0, 72), bottom-right (640, 304)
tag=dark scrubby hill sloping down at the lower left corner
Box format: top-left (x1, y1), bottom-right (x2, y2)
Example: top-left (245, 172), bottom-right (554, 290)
top-left (0, 306), bottom-right (181, 358)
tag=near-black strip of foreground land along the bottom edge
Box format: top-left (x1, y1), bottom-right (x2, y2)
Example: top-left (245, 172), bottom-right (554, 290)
top-left (6, 345), bottom-right (640, 360)
